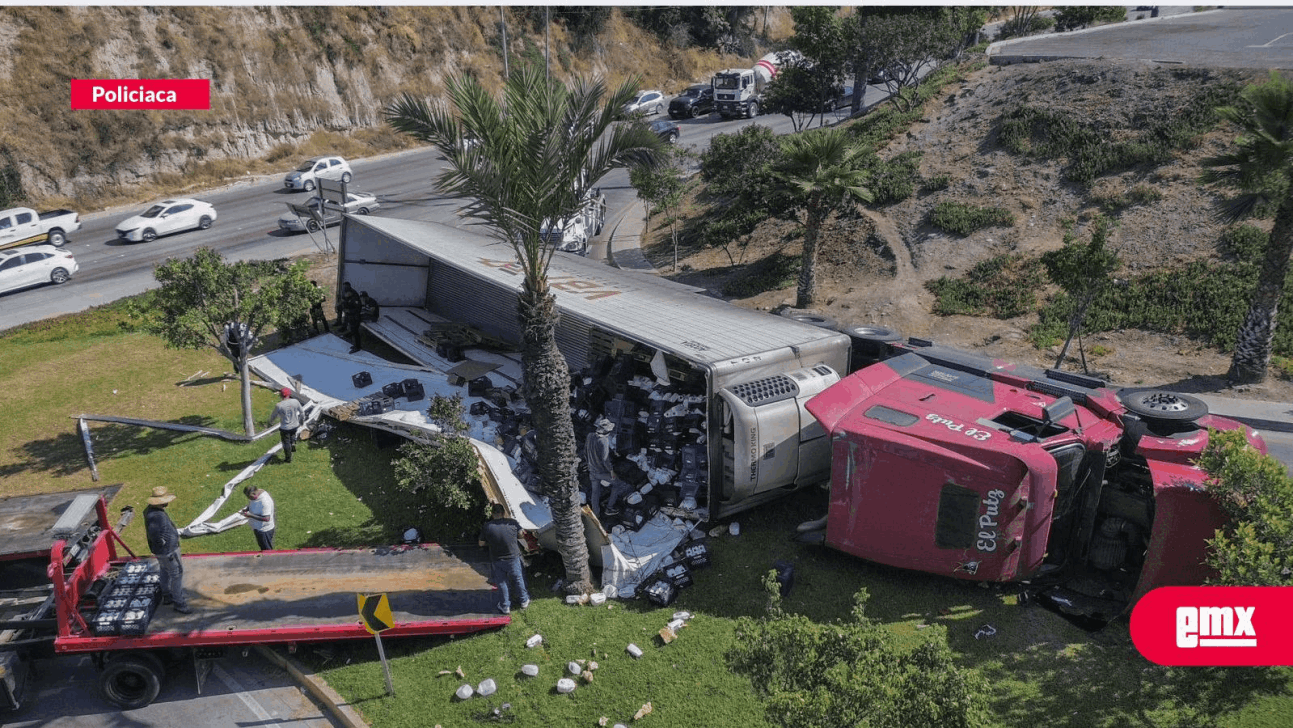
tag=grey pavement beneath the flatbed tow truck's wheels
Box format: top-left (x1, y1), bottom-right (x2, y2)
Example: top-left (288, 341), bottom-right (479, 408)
top-left (0, 654), bottom-right (336, 728)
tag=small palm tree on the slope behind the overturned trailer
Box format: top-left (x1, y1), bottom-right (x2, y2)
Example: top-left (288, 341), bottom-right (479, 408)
top-left (776, 128), bottom-right (871, 308)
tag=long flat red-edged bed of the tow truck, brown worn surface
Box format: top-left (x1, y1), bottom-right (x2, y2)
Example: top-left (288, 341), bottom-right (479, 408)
top-left (56, 544), bottom-right (509, 652)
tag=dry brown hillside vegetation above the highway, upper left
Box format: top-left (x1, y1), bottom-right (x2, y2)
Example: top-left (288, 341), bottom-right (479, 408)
top-left (0, 6), bottom-right (789, 211)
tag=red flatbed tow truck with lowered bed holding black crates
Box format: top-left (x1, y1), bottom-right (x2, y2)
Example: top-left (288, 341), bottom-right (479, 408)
top-left (0, 487), bottom-right (509, 710)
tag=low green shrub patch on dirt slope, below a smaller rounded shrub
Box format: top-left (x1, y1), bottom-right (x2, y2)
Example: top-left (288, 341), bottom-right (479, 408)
top-left (924, 253), bottom-right (1046, 318)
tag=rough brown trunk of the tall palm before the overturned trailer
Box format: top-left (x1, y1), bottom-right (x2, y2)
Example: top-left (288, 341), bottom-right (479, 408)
top-left (518, 279), bottom-right (593, 594)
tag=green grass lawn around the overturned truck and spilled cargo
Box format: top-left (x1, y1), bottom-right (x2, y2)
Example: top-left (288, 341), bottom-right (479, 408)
top-left (0, 298), bottom-right (1293, 728)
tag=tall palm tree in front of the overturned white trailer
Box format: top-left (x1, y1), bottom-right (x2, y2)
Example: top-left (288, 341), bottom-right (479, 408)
top-left (385, 67), bottom-right (663, 594)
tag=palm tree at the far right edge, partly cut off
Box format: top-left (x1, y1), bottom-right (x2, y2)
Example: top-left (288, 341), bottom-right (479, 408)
top-left (1201, 72), bottom-right (1293, 384)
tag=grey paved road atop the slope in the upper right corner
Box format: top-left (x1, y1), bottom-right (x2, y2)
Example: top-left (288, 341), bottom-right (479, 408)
top-left (989, 8), bottom-right (1293, 69)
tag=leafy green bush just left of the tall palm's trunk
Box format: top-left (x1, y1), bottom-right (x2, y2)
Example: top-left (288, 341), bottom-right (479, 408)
top-left (393, 394), bottom-right (487, 542)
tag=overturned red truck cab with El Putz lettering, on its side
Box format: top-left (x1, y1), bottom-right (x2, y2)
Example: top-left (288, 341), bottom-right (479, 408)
top-left (802, 339), bottom-right (1266, 622)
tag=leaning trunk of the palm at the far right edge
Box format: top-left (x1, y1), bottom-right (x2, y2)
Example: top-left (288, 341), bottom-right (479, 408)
top-left (1226, 198), bottom-right (1293, 384)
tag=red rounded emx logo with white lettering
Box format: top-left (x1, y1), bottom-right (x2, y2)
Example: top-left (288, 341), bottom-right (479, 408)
top-left (1131, 587), bottom-right (1293, 665)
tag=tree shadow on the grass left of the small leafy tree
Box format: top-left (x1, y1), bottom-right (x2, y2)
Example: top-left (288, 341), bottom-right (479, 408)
top-left (0, 415), bottom-right (213, 477)
